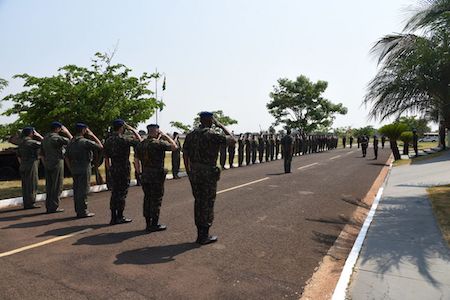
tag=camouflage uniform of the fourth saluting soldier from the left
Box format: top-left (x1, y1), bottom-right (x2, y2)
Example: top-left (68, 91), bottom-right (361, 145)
top-left (104, 132), bottom-right (138, 217)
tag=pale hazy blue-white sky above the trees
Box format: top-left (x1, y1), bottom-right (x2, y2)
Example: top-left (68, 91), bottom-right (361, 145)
top-left (0, 0), bottom-right (418, 132)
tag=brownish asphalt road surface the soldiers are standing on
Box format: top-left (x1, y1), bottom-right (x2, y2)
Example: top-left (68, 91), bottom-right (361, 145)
top-left (0, 148), bottom-right (389, 299)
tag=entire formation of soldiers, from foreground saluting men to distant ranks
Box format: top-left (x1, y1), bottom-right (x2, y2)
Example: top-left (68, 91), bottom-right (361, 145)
top-left (17, 112), bottom-right (385, 245)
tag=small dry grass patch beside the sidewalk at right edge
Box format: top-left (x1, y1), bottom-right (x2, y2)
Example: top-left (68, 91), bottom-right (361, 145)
top-left (427, 185), bottom-right (450, 245)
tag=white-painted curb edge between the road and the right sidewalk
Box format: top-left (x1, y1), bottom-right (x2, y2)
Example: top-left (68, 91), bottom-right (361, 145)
top-left (331, 163), bottom-right (392, 300)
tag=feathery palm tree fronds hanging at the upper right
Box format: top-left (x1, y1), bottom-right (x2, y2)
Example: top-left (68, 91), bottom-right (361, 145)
top-left (364, 0), bottom-right (450, 146)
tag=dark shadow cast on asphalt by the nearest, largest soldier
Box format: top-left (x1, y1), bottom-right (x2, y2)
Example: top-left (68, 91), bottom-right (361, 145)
top-left (114, 243), bottom-right (200, 265)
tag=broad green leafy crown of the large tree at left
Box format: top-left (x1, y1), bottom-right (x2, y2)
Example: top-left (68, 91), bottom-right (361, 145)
top-left (2, 53), bottom-right (164, 137)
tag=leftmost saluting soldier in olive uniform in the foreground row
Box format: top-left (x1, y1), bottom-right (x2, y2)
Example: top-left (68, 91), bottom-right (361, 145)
top-left (17, 127), bottom-right (42, 209)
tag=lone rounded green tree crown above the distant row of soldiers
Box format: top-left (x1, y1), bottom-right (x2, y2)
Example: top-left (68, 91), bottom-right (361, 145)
top-left (267, 75), bottom-right (347, 134)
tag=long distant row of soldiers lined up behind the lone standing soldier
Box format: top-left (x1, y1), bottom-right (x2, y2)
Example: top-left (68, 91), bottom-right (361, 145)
top-left (219, 131), bottom-right (338, 169)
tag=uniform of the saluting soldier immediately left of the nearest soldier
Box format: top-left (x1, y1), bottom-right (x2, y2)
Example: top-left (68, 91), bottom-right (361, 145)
top-left (136, 137), bottom-right (171, 224)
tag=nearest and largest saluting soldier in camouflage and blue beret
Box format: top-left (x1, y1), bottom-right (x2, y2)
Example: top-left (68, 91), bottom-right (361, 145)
top-left (183, 112), bottom-right (231, 245)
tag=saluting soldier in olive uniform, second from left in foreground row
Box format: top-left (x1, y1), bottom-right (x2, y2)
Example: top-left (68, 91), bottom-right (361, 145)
top-left (42, 122), bottom-right (73, 214)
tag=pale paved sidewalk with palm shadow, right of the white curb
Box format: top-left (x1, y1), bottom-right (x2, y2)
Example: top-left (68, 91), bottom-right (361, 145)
top-left (347, 152), bottom-right (450, 300)
